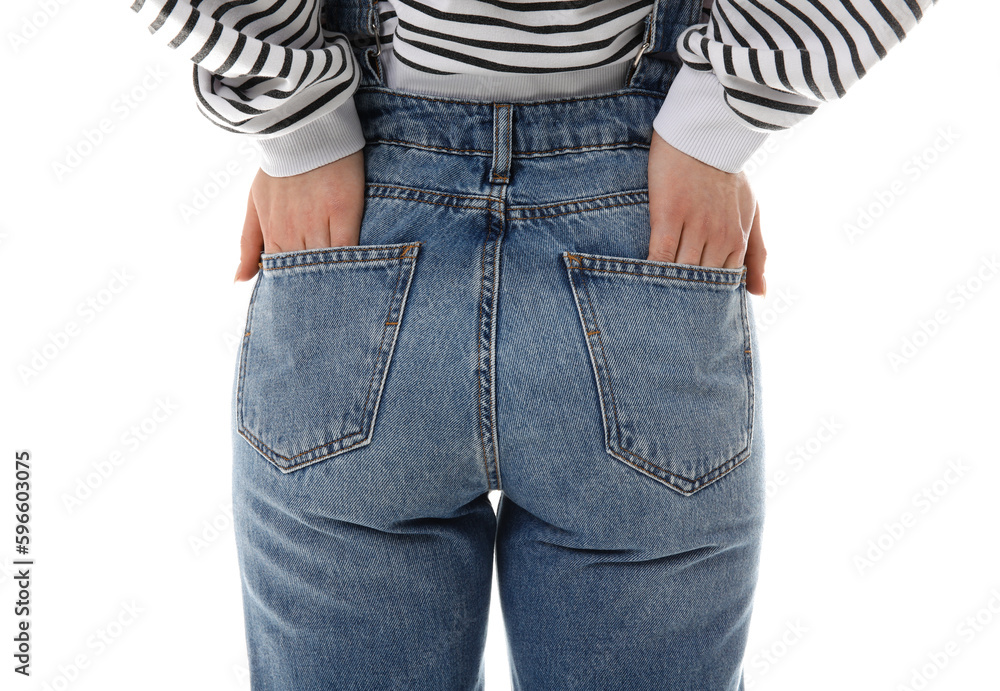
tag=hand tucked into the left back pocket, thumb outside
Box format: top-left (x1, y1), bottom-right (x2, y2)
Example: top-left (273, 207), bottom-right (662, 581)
top-left (234, 149), bottom-right (365, 281)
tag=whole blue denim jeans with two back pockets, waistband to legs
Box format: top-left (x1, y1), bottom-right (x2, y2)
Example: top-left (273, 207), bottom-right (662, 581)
top-left (232, 0), bottom-right (764, 691)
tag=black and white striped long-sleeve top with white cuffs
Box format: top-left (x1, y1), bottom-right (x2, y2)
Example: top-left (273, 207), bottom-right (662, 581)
top-left (131, 0), bottom-right (936, 176)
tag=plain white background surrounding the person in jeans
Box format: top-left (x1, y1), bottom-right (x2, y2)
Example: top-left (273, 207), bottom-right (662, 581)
top-left (0, 0), bottom-right (1000, 691)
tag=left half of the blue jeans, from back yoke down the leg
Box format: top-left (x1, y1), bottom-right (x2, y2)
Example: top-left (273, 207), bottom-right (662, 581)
top-left (232, 177), bottom-right (504, 691)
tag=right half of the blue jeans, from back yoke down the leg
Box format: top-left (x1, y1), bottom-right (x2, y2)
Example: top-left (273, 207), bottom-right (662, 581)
top-left (496, 172), bottom-right (764, 691)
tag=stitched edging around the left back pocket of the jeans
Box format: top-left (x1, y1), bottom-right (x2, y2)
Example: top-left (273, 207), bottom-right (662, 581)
top-left (237, 243), bottom-right (423, 473)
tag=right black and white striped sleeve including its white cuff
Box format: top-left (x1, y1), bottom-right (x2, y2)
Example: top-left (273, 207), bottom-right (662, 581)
top-left (653, 0), bottom-right (936, 173)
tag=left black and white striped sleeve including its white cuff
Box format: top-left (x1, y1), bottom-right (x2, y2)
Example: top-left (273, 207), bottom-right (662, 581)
top-left (131, 0), bottom-right (364, 177)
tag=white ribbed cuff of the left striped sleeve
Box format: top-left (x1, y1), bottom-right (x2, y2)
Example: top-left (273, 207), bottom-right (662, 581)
top-left (251, 96), bottom-right (365, 178)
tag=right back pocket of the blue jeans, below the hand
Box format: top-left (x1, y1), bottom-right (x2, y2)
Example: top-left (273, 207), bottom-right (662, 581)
top-left (562, 252), bottom-right (754, 495)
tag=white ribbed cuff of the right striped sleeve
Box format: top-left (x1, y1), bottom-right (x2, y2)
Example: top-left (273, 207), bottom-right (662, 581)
top-left (653, 64), bottom-right (772, 173)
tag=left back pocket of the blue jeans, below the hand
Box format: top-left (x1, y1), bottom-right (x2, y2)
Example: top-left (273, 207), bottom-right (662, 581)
top-left (236, 242), bottom-right (423, 473)
